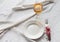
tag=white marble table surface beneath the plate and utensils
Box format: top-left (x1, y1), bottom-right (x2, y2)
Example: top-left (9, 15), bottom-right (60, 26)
top-left (0, 0), bottom-right (60, 42)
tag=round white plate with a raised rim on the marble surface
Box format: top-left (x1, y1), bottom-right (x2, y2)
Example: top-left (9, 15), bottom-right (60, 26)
top-left (24, 20), bottom-right (44, 39)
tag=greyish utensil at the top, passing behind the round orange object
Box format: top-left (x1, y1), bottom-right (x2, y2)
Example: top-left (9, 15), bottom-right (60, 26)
top-left (12, 1), bottom-right (54, 11)
